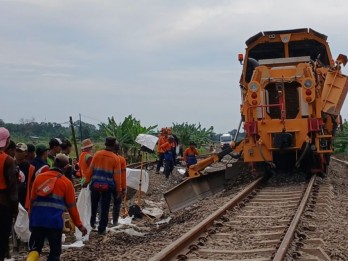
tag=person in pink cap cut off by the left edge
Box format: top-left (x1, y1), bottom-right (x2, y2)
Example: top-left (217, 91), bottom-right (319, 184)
top-left (0, 127), bottom-right (18, 261)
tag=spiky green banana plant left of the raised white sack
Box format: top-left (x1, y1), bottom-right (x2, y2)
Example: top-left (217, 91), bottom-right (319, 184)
top-left (99, 115), bottom-right (157, 162)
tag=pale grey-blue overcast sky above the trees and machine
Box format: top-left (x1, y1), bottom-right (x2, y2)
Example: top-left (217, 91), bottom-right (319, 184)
top-left (0, 0), bottom-right (348, 132)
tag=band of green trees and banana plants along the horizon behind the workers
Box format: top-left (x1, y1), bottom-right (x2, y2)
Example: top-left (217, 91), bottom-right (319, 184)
top-left (0, 115), bottom-right (245, 147)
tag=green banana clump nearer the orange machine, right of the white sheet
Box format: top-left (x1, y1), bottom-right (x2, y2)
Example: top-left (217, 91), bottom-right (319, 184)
top-left (172, 122), bottom-right (214, 147)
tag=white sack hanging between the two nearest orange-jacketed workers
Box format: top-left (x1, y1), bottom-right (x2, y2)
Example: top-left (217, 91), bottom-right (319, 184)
top-left (75, 187), bottom-right (92, 241)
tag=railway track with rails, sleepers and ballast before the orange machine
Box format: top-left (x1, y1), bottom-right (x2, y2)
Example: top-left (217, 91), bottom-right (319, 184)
top-left (150, 175), bottom-right (315, 261)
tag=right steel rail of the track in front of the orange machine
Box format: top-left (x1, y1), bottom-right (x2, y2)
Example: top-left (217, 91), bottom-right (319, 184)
top-left (273, 172), bottom-right (316, 261)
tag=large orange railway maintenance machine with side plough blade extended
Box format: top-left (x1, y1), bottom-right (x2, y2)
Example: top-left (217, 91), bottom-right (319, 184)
top-left (164, 28), bottom-right (348, 211)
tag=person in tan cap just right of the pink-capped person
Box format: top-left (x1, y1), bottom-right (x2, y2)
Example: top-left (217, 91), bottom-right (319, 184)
top-left (15, 143), bottom-right (35, 209)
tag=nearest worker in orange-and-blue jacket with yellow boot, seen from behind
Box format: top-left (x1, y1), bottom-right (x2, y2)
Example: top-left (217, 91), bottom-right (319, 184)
top-left (27, 154), bottom-right (87, 261)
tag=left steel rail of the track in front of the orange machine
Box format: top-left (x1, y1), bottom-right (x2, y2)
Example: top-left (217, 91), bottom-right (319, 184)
top-left (149, 177), bottom-right (263, 261)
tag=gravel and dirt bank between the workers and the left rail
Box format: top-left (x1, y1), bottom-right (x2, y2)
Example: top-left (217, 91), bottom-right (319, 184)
top-left (58, 160), bottom-right (252, 261)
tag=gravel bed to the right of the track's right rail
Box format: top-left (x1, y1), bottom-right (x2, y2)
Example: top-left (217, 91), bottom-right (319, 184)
top-left (287, 155), bottom-right (348, 260)
